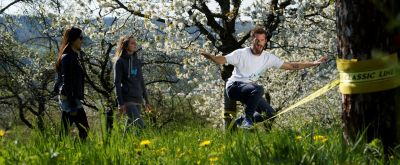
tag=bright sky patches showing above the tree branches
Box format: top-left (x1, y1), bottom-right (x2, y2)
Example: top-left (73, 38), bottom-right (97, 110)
top-left (0, 0), bottom-right (255, 14)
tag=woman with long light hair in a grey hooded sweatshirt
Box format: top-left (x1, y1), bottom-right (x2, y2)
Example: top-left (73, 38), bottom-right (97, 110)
top-left (114, 36), bottom-right (151, 132)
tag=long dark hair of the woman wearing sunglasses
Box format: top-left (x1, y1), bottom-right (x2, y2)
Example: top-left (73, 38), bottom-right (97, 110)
top-left (56, 27), bottom-right (82, 72)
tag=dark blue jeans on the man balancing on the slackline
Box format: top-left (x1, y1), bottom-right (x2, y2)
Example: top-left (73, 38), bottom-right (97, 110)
top-left (226, 81), bottom-right (275, 120)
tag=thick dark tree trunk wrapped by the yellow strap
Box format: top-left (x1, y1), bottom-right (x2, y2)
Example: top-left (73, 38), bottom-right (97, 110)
top-left (336, 0), bottom-right (400, 151)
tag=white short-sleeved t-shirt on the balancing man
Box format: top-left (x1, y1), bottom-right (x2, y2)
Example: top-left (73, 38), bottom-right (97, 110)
top-left (225, 47), bottom-right (284, 87)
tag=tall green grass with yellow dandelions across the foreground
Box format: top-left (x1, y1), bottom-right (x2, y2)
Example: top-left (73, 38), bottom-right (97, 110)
top-left (0, 114), bottom-right (400, 164)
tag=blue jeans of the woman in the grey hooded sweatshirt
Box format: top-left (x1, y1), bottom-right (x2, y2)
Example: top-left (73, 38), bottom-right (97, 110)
top-left (125, 102), bottom-right (145, 129)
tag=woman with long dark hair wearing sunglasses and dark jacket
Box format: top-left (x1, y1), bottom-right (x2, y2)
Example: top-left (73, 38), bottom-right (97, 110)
top-left (56, 27), bottom-right (89, 139)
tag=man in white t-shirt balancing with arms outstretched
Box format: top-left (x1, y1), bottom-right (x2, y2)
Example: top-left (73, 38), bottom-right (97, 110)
top-left (201, 27), bottom-right (328, 129)
